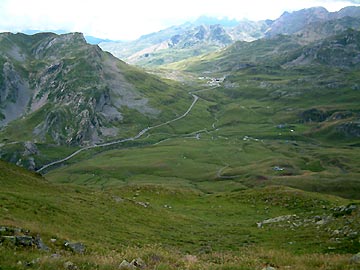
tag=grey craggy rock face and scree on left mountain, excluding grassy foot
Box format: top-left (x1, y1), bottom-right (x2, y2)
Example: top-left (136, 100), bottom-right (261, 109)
top-left (0, 33), bottom-right (164, 145)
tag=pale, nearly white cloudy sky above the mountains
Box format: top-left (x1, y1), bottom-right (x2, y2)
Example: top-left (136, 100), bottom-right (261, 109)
top-left (0, 0), bottom-right (360, 40)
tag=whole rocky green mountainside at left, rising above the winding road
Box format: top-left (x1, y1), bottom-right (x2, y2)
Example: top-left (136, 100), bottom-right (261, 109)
top-left (0, 33), bottom-right (191, 168)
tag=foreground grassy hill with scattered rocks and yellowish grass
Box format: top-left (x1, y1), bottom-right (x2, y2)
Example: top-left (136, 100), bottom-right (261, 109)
top-left (0, 159), bottom-right (360, 269)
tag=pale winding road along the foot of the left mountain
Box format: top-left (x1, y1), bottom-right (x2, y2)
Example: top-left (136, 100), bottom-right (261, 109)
top-left (36, 94), bottom-right (199, 173)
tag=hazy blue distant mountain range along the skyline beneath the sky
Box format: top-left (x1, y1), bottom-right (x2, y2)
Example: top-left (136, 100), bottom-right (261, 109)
top-left (99, 7), bottom-right (360, 66)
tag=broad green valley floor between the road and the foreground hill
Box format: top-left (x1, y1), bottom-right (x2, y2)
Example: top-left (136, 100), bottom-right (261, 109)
top-left (47, 63), bottom-right (360, 198)
